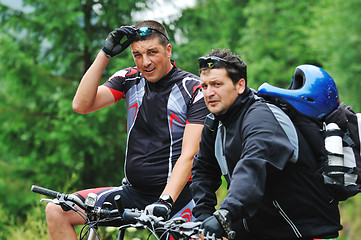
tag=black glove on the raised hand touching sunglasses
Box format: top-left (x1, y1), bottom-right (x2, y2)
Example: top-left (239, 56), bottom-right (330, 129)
top-left (102, 26), bottom-right (136, 58)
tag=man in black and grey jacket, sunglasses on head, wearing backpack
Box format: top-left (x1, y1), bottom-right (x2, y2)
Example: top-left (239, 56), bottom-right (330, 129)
top-left (191, 47), bottom-right (342, 240)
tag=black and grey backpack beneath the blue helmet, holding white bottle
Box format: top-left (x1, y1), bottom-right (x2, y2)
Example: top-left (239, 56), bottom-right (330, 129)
top-left (259, 94), bottom-right (361, 201)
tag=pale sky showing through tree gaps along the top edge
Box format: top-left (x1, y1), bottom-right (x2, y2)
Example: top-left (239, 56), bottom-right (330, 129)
top-left (0, 0), bottom-right (196, 23)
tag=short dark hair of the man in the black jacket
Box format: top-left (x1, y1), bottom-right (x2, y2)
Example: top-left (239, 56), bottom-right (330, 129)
top-left (199, 49), bottom-right (247, 85)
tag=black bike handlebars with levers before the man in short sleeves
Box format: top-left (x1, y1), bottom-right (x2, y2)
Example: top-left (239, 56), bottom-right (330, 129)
top-left (31, 185), bottom-right (201, 240)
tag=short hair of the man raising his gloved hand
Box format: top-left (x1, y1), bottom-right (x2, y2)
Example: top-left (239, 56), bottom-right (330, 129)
top-left (134, 20), bottom-right (169, 47)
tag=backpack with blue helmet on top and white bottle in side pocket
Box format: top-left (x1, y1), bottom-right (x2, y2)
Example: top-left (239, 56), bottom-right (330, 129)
top-left (257, 64), bottom-right (361, 201)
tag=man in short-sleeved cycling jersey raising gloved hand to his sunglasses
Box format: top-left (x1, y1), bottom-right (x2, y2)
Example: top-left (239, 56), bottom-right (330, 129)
top-left (46, 21), bottom-right (208, 239)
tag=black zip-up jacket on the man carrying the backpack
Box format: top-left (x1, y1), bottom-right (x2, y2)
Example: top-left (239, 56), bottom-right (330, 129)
top-left (191, 88), bottom-right (342, 239)
